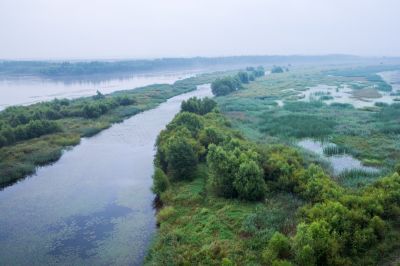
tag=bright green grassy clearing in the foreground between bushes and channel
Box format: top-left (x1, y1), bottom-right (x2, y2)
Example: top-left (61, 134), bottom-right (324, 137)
top-left (147, 165), bottom-right (303, 265)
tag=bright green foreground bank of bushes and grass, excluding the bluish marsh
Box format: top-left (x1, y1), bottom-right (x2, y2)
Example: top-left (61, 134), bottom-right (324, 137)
top-left (147, 96), bottom-right (400, 265)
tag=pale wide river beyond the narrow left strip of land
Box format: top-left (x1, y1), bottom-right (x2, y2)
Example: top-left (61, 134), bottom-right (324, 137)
top-left (0, 70), bottom-right (195, 110)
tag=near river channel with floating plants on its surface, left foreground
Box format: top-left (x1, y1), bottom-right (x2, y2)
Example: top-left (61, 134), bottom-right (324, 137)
top-left (0, 85), bottom-right (211, 265)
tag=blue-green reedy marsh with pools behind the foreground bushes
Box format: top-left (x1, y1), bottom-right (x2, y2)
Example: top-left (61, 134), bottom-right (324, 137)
top-left (216, 66), bottom-right (400, 187)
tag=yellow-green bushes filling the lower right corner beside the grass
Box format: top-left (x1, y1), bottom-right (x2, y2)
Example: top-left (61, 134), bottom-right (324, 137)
top-left (263, 148), bottom-right (400, 265)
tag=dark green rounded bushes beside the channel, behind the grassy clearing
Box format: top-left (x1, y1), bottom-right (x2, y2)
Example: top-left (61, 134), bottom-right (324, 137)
top-left (153, 98), bottom-right (265, 200)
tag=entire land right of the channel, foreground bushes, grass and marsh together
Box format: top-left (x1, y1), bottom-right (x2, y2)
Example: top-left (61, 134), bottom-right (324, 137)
top-left (146, 65), bottom-right (400, 265)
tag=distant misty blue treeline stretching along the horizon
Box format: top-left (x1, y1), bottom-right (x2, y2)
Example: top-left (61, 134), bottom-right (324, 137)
top-left (0, 55), bottom-right (400, 77)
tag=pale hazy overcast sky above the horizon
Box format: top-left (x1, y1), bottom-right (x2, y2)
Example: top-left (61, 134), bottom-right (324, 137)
top-left (0, 0), bottom-right (400, 59)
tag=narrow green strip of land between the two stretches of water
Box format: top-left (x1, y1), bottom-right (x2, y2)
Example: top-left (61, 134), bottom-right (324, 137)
top-left (0, 72), bottom-right (233, 187)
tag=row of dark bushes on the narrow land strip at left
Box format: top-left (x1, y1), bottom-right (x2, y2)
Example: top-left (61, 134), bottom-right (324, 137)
top-left (0, 92), bottom-right (135, 148)
